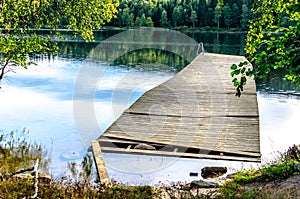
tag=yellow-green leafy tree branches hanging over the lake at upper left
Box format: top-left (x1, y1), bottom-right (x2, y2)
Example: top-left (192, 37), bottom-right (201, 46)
top-left (0, 0), bottom-right (118, 80)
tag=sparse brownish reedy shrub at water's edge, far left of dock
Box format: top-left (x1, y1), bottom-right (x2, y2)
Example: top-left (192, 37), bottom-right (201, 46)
top-left (0, 129), bottom-right (49, 198)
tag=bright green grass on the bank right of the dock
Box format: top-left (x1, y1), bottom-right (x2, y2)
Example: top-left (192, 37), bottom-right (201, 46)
top-left (218, 145), bottom-right (300, 199)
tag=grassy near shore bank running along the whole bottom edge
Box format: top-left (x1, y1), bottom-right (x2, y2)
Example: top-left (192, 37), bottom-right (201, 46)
top-left (0, 130), bottom-right (300, 199)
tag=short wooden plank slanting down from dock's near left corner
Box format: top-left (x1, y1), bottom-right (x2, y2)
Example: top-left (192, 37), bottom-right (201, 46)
top-left (92, 141), bottom-right (110, 185)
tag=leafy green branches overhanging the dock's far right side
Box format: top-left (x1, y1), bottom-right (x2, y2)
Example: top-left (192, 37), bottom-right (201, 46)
top-left (231, 0), bottom-right (300, 95)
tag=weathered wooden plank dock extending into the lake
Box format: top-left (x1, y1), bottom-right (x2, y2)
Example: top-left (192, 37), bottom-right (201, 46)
top-left (92, 53), bottom-right (261, 185)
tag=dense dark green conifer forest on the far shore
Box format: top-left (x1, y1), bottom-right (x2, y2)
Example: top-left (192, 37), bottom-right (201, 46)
top-left (110, 0), bottom-right (253, 30)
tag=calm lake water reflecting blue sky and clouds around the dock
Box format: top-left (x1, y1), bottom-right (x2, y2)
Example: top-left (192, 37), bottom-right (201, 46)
top-left (0, 31), bottom-right (300, 184)
